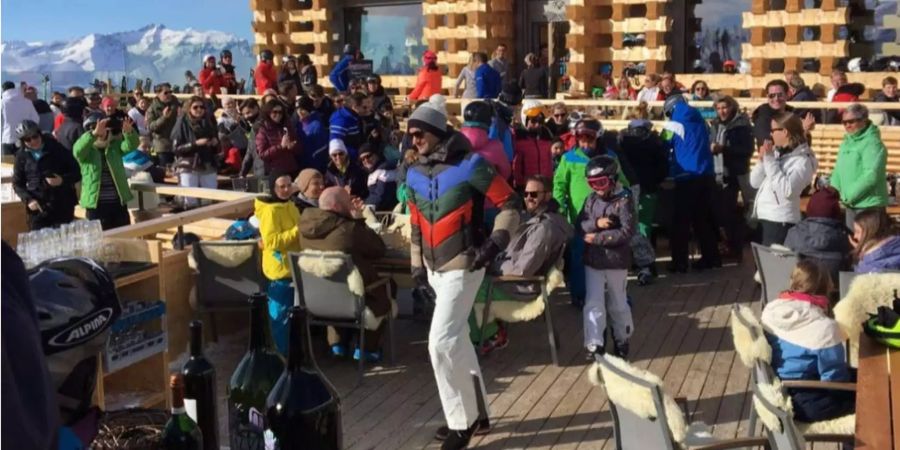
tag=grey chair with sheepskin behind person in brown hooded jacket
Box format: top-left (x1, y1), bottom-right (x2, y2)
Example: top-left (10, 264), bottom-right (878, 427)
top-left (289, 250), bottom-right (396, 381)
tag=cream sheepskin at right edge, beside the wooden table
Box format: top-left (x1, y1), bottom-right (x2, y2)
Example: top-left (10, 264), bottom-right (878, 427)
top-left (834, 273), bottom-right (900, 354)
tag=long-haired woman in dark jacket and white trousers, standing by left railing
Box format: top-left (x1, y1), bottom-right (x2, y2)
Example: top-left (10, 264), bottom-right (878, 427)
top-left (172, 95), bottom-right (219, 208)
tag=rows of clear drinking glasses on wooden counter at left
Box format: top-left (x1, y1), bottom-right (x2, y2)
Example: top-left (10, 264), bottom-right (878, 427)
top-left (16, 220), bottom-right (103, 267)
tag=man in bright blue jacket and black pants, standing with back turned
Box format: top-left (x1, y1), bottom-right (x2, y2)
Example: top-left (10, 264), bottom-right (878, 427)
top-left (663, 94), bottom-right (722, 272)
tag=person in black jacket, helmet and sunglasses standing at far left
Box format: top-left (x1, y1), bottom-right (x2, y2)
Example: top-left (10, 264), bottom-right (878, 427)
top-left (13, 119), bottom-right (81, 231)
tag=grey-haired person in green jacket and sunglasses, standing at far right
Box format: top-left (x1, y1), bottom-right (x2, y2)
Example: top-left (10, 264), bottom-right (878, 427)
top-left (831, 103), bottom-right (888, 229)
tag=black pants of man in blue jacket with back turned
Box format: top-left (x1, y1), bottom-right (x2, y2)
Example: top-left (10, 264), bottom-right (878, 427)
top-left (670, 177), bottom-right (721, 268)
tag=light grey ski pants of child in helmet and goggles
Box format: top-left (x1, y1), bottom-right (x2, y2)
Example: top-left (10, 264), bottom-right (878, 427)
top-left (584, 267), bottom-right (634, 348)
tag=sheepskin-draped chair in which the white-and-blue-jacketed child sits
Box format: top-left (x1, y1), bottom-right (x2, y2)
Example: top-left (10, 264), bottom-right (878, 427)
top-left (731, 305), bottom-right (856, 442)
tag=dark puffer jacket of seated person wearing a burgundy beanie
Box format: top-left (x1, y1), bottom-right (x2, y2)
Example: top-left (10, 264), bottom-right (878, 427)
top-left (784, 217), bottom-right (850, 280)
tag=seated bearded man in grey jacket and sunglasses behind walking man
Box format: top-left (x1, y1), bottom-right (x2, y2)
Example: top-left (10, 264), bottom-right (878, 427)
top-left (469, 175), bottom-right (575, 354)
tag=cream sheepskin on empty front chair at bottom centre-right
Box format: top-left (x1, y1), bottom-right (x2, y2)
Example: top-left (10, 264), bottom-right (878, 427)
top-left (588, 355), bottom-right (688, 446)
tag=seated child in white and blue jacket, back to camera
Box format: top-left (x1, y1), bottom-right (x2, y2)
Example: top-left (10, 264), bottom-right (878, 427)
top-left (761, 260), bottom-right (854, 422)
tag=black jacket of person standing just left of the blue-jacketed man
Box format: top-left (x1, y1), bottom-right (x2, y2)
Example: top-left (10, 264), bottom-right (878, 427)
top-left (619, 127), bottom-right (669, 194)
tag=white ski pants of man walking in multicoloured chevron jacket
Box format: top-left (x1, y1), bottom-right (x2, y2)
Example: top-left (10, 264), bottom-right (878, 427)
top-left (428, 270), bottom-right (486, 430)
